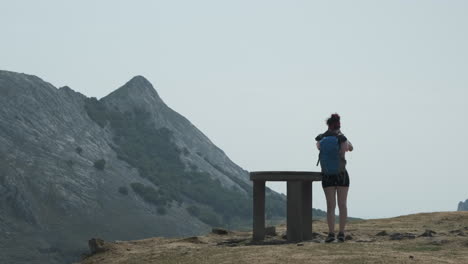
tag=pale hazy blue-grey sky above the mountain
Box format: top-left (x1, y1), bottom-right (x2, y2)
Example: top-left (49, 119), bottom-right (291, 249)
top-left (0, 0), bottom-right (468, 218)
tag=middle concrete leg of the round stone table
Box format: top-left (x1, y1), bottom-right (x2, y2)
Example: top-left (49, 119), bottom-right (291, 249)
top-left (286, 181), bottom-right (303, 242)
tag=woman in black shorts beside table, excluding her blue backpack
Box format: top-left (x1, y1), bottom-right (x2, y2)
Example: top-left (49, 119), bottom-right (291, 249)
top-left (315, 114), bottom-right (353, 243)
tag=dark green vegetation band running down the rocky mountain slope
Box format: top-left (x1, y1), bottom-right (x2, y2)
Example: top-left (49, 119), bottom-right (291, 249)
top-left (85, 98), bottom-right (286, 227)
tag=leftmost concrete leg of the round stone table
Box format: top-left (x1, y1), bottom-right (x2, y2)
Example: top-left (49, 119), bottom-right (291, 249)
top-left (253, 181), bottom-right (265, 241)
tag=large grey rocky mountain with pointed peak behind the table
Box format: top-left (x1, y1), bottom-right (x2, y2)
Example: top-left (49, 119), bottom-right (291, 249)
top-left (0, 71), bottom-right (286, 263)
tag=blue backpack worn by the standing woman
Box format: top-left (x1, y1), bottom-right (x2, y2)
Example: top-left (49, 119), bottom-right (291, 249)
top-left (317, 136), bottom-right (341, 175)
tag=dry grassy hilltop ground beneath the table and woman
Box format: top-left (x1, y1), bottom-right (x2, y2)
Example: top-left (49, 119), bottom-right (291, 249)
top-left (80, 212), bottom-right (468, 264)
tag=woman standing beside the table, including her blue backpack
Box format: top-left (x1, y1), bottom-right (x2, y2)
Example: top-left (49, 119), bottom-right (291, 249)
top-left (315, 114), bottom-right (353, 243)
